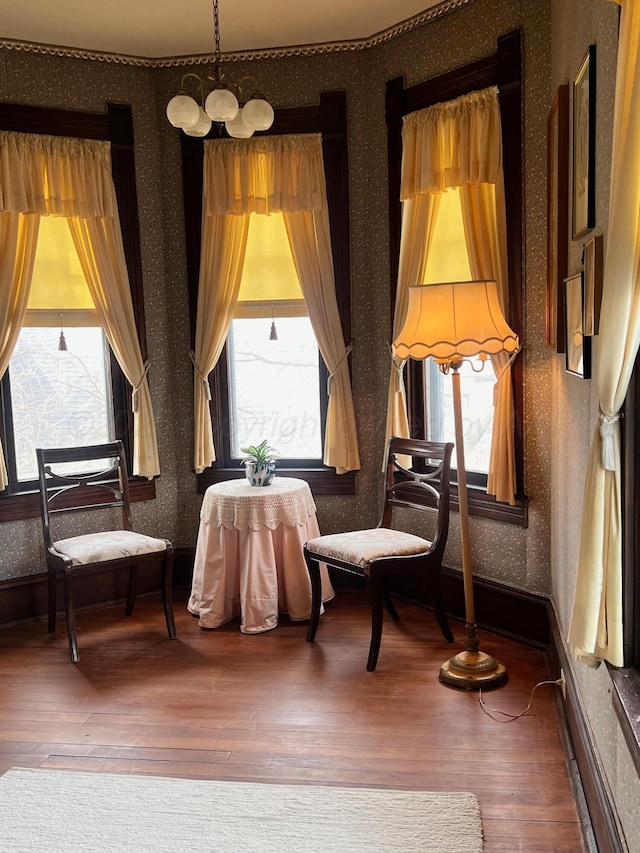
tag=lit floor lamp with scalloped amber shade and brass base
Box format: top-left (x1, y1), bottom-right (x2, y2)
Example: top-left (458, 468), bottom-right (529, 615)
top-left (393, 281), bottom-right (519, 690)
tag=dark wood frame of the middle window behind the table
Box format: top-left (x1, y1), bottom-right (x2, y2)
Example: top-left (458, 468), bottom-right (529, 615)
top-left (180, 92), bottom-right (355, 495)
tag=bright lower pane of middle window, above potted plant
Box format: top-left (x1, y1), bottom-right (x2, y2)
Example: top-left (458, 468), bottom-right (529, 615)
top-left (227, 317), bottom-right (322, 459)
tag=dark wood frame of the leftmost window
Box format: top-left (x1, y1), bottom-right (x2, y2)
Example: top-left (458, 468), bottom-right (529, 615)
top-left (0, 103), bottom-right (155, 522)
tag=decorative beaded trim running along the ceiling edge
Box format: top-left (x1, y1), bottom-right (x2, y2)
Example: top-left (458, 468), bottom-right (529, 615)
top-left (0, 0), bottom-right (473, 68)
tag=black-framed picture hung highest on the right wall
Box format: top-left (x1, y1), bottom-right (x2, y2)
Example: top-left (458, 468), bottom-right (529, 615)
top-left (572, 44), bottom-right (596, 240)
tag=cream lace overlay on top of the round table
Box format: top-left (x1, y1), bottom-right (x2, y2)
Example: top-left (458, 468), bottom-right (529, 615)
top-left (200, 477), bottom-right (316, 530)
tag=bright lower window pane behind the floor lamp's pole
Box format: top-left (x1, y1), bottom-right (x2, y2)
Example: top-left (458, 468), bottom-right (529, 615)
top-left (425, 358), bottom-right (495, 474)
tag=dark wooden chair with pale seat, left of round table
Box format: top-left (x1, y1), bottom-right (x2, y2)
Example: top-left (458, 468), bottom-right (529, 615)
top-left (36, 441), bottom-right (176, 663)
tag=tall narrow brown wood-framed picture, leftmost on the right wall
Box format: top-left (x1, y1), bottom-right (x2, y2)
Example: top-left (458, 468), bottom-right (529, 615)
top-left (546, 83), bottom-right (569, 352)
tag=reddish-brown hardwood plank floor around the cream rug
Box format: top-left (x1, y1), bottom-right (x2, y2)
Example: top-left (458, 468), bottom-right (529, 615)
top-left (0, 591), bottom-right (584, 853)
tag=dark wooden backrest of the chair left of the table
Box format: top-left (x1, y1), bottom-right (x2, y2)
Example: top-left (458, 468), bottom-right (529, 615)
top-left (36, 441), bottom-right (131, 547)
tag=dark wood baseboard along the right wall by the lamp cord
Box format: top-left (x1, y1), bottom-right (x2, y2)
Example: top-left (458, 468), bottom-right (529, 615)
top-left (548, 603), bottom-right (628, 853)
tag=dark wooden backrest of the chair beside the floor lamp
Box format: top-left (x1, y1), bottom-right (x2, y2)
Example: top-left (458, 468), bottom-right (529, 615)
top-left (380, 437), bottom-right (453, 558)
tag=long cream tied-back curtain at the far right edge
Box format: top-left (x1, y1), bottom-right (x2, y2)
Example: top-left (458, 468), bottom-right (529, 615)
top-left (569, 0), bottom-right (640, 666)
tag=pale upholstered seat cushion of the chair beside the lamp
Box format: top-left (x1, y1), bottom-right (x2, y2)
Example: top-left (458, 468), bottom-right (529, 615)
top-left (307, 527), bottom-right (431, 567)
